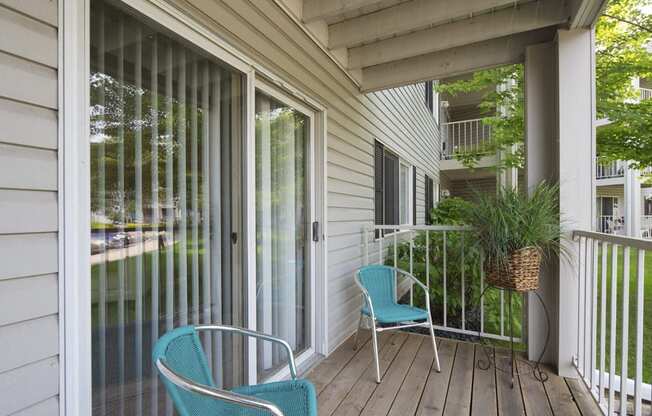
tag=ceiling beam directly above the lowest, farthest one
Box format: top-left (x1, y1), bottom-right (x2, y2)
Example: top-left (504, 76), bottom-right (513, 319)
top-left (348, 0), bottom-right (569, 68)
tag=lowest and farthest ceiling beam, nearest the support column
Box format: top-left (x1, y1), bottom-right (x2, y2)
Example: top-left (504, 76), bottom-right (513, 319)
top-left (361, 28), bottom-right (556, 92)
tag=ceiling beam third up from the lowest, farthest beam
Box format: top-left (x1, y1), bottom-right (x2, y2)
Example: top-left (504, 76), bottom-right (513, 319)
top-left (328, 0), bottom-right (514, 49)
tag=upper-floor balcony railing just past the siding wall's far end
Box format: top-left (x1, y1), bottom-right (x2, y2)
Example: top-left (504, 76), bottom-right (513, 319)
top-left (441, 118), bottom-right (491, 159)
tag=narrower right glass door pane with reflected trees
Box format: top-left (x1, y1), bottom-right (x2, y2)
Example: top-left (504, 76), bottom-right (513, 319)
top-left (256, 91), bottom-right (313, 380)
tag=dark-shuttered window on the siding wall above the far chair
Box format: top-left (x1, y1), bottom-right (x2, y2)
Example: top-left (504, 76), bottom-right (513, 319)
top-left (374, 141), bottom-right (411, 229)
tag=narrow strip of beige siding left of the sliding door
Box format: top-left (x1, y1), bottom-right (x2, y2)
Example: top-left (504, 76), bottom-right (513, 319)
top-left (0, 0), bottom-right (59, 415)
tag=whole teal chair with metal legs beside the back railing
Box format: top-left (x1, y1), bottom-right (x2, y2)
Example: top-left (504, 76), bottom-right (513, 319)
top-left (354, 265), bottom-right (440, 383)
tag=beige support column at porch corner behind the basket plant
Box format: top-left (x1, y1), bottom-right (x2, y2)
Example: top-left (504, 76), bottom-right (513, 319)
top-left (525, 30), bottom-right (595, 376)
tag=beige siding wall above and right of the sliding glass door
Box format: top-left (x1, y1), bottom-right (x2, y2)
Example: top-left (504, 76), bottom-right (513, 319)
top-left (183, 0), bottom-right (439, 349)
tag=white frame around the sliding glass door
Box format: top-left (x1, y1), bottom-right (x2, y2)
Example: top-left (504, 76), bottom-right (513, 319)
top-left (58, 0), bottom-right (329, 416)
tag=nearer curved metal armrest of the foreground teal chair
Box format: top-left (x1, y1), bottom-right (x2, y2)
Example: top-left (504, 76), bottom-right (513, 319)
top-left (156, 359), bottom-right (284, 416)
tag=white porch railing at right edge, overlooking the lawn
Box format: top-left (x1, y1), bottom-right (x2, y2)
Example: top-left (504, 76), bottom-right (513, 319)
top-left (573, 231), bottom-right (652, 416)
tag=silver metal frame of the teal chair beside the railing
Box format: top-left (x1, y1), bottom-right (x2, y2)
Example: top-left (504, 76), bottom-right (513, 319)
top-left (353, 266), bottom-right (441, 383)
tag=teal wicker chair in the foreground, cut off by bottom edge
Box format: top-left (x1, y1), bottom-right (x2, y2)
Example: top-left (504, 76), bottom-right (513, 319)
top-left (153, 325), bottom-right (317, 416)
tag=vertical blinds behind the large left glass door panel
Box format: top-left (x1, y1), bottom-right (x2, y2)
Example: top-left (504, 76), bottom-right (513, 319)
top-left (89, 1), bottom-right (243, 416)
